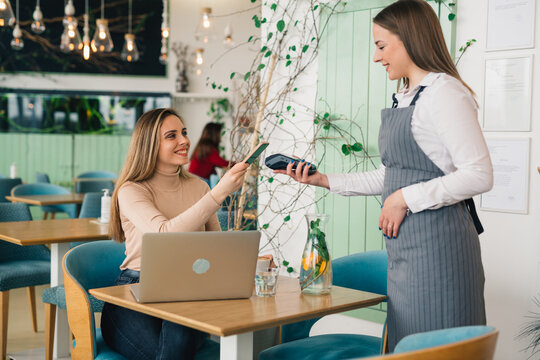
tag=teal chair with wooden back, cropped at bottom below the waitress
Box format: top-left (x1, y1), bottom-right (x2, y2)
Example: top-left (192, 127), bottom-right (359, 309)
top-left (358, 326), bottom-right (499, 360)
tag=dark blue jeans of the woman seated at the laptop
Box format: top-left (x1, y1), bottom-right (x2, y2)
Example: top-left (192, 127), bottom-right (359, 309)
top-left (101, 269), bottom-right (206, 360)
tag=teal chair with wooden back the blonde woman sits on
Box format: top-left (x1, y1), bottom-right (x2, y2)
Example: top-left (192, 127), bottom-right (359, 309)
top-left (63, 240), bottom-right (219, 360)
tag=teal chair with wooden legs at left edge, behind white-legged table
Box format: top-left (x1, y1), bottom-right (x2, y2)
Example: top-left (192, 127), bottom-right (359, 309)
top-left (0, 203), bottom-right (51, 359)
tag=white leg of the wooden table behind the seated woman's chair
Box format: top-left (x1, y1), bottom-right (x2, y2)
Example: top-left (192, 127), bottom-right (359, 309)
top-left (51, 243), bottom-right (69, 359)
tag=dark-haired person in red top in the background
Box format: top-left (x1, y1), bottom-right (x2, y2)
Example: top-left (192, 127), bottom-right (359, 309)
top-left (188, 123), bottom-right (233, 183)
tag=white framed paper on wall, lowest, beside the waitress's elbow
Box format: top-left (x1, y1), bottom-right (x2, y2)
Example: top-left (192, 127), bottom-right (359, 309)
top-left (480, 137), bottom-right (531, 214)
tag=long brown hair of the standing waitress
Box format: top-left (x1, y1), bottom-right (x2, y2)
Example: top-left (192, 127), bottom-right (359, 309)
top-left (373, 0), bottom-right (474, 96)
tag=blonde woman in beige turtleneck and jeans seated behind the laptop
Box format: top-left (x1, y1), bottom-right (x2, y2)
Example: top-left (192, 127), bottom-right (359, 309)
top-left (101, 109), bottom-right (248, 359)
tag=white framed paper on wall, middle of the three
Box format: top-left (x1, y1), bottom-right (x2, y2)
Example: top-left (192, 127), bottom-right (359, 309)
top-left (482, 54), bottom-right (534, 131)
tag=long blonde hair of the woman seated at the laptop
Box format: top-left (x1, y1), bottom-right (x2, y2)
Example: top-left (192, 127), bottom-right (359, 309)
top-left (109, 108), bottom-right (190, 242)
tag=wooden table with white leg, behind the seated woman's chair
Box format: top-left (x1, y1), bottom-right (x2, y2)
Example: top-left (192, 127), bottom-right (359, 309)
top-left (0, 219), bottom-right (110, 358)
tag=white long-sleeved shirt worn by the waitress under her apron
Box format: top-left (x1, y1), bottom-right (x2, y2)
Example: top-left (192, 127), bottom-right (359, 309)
top-left (327, 73), bottom-right (493, 213)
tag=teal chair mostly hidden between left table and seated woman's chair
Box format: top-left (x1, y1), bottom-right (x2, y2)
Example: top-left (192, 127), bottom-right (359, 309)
top-left (41, 192), bottom-right (103, 360)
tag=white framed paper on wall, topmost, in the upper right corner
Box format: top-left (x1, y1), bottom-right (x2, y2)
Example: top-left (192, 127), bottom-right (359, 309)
top-left (486, 0), bottom-right (536, 51)
